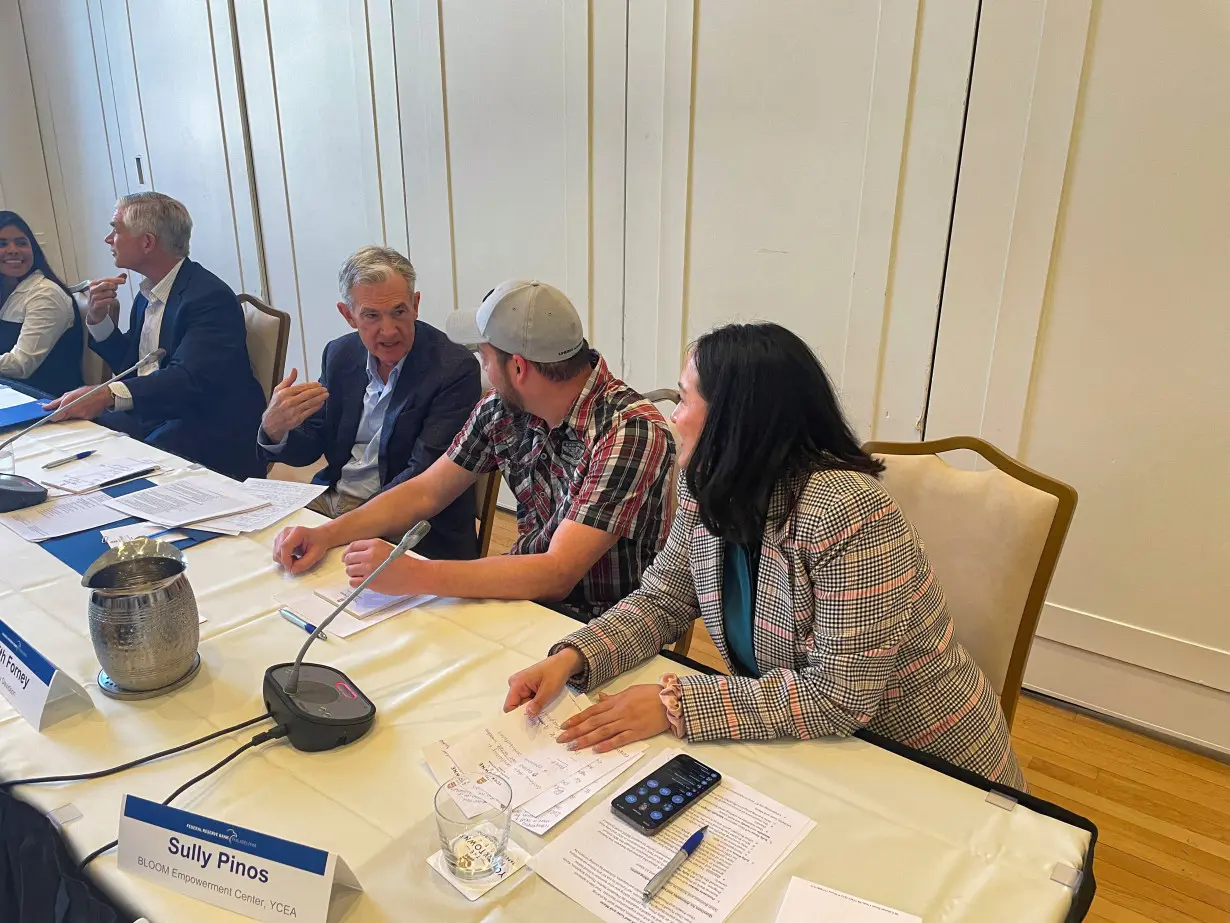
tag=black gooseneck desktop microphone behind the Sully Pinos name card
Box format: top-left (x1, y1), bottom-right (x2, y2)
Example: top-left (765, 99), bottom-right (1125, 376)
top-left (264, 522), bottom-right (432, 751)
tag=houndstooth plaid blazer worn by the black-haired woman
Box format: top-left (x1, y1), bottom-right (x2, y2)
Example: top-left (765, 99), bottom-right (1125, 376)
top-left (552, 471), bottom-right (1025, 789)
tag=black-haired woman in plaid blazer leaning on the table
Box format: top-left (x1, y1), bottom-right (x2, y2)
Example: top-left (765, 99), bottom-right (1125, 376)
top-left (504, 324), bottom-right (1025, 788)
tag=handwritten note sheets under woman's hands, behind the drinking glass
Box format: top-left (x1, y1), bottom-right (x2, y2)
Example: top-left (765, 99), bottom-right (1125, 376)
top-left (423, 690), bottom-right (646, 833)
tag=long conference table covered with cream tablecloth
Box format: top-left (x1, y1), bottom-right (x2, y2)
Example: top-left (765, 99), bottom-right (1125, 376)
top-left (0, 422), bottom-right (1091, 923)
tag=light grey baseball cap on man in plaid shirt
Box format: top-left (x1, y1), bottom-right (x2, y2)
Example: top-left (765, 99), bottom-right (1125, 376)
top-left (445, 279), bottom-right (585, 362)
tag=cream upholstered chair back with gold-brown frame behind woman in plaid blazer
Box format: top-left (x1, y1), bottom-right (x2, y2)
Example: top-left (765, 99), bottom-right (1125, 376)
top-left (863, 436), bottom-right (1076, 727)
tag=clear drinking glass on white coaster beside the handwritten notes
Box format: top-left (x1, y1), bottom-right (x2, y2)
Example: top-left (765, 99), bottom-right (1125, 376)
top-left (435, 775), bottom-right (513, 881)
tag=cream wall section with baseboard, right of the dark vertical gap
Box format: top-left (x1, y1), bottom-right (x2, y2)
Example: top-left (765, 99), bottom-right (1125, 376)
top-left (927, 0), bottom-right (1230, 753)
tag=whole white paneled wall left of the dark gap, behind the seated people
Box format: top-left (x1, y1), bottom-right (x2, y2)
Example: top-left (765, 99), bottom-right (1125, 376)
top-left (10, 0), bottom-right (977, 438)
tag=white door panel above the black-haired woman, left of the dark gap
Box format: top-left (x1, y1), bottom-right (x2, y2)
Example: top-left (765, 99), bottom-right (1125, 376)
top-left (624, 0), bottom-right (978, 441)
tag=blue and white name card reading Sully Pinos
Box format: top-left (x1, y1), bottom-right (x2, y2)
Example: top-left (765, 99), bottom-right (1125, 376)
top-left (119, 795), bottom-right (363, 923)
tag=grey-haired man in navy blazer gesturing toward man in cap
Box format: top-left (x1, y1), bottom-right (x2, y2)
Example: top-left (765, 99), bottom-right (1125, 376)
top-left (256, 246), bottom-right (482, 560)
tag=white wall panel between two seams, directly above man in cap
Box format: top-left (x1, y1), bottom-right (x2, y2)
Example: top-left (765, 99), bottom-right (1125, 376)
top-left (394, 0), bottom-right (626, 368)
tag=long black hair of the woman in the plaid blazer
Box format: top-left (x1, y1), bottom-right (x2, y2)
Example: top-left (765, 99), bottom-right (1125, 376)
top-left (684, 324), bottom-right (884, 544)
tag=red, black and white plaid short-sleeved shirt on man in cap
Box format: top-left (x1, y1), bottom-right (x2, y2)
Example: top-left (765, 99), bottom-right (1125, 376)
top-left (448, 352), bottom-right (675, 615)
